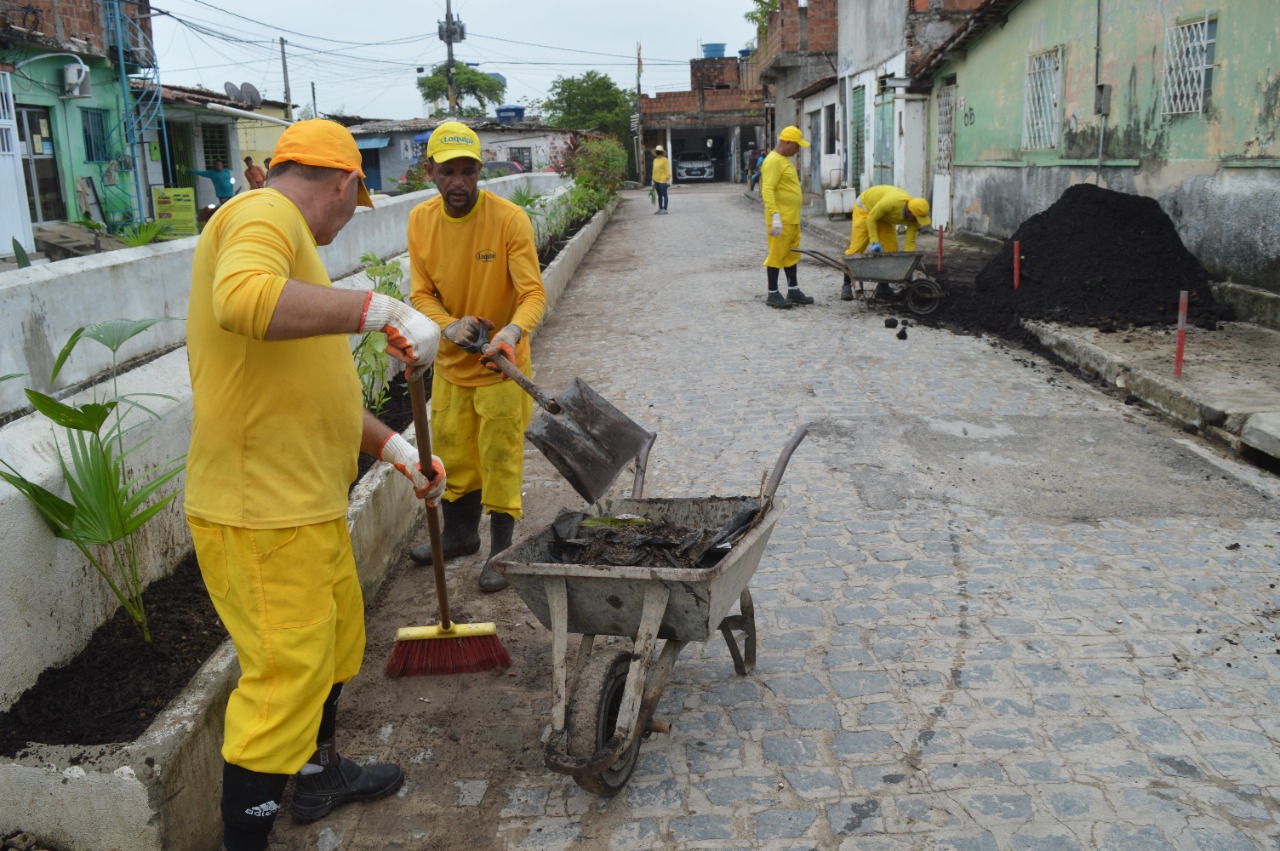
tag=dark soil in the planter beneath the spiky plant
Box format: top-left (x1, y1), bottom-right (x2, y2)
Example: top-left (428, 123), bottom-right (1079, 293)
top-left (0, 554), bottom-right (227, 761)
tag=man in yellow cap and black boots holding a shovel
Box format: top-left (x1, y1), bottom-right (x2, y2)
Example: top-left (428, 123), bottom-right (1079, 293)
top-left (408, 122), bottom-right (547, 591)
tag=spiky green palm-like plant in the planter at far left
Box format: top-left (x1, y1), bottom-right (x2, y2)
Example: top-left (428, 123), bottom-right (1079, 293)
top-left (0, 317), bottom-right (183, 641)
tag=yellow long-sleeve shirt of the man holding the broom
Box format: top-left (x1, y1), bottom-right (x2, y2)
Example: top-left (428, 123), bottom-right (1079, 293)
top-left (184, 189), bottom-right (364, 529)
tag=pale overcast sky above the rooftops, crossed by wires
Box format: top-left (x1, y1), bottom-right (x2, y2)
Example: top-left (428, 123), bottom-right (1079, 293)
top-left (152, 0), bottom-right (755, 119)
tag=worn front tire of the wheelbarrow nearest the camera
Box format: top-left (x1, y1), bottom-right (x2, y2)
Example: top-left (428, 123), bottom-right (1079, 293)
top-left (566, 648), bottom-right (641, 797)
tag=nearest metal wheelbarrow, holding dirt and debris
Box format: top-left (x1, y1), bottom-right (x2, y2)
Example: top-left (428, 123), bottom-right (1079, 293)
top-left (493, 427), bottom-right (808, 797)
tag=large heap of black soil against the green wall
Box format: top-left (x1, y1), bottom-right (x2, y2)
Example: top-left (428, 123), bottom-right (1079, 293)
top-left (931, 183), bottom-right (1231, 342)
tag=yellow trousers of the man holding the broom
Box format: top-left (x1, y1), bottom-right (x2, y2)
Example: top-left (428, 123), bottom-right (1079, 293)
top-left (187, 516), bottom-right (365, 774)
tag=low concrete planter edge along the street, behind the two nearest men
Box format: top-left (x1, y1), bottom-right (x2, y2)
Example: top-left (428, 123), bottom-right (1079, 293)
top-left (0, 191), bottom-right (617, 851)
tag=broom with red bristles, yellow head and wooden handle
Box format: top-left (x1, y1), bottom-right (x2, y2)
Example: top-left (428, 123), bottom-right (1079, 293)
top-left (387, 365), bottom-right (511, 677)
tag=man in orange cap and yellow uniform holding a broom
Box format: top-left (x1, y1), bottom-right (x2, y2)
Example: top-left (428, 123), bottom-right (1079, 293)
top-left (186, 119), bottom-right (444, 851)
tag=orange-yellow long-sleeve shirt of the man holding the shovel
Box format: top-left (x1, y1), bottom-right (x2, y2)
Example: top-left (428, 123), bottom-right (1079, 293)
top-left (408, 189), bottom-right (547, 386)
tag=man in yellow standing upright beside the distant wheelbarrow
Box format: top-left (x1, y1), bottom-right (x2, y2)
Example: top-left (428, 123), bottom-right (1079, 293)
top-left (760, 127), bottom-right (813, 310)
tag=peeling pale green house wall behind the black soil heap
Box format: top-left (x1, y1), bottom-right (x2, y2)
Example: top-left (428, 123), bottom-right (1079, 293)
top-left (929, 0), bottom-right (1280, 292)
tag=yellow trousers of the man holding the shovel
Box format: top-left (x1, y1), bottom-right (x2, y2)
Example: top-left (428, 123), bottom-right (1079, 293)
top-left (431, 372), bottom-right (534, 520)
